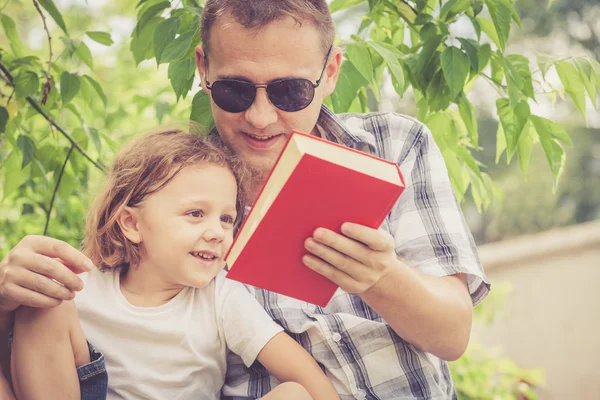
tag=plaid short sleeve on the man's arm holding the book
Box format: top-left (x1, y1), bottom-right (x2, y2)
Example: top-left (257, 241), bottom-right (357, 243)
top-left (389, 121), bottom-right (490, 305)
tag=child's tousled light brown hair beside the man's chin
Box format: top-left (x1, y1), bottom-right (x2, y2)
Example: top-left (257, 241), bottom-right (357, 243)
top-left (82, 123), bottom-right (252, 270)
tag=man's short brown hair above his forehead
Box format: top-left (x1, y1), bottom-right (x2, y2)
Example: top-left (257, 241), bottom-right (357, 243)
top-left (200, 0), bottom-right (335, 55)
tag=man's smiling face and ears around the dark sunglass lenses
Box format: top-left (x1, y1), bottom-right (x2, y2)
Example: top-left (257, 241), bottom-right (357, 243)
top-left (196, 15), bottom-right (341, 176)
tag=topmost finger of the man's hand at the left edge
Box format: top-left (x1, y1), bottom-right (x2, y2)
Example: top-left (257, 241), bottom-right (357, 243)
top-left (23, 236), bottom-right (94, 273)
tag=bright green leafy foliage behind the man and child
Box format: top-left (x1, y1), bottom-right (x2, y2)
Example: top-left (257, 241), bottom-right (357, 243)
top-left (0, 0), bottom-right (600, 398)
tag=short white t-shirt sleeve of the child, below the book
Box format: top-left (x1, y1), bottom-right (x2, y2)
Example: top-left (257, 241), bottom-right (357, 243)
top-left (215, 271), bottom-right (283, 367)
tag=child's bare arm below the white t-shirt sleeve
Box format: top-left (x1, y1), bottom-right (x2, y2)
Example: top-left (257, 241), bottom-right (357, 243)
top-left (257, 332), bottom-right (339, 400)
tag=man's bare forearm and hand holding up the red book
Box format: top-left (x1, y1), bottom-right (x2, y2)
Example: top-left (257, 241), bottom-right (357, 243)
top-left (304, 223), bottom-right (473, 360)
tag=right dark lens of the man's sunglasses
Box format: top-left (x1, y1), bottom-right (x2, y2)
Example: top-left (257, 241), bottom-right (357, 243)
top-left (267, 79), bottom-right (315, 112)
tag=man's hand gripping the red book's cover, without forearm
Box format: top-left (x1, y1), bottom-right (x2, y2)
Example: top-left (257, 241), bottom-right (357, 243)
top-left (303, 223), bottom-right (398, 294)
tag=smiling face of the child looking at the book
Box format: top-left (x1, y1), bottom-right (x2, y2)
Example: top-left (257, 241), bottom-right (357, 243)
top-left (137, 164), bottom-right (237, 288)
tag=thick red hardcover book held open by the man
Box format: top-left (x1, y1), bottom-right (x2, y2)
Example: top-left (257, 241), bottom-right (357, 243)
top-left (226, 131), bottom-right (404, 307)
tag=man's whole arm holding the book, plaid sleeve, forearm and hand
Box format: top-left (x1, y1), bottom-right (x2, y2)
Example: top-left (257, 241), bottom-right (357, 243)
top-left (305, 121), bottom-right (489, 360)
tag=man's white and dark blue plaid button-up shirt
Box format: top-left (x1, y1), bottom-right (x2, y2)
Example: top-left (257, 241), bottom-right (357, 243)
top-left (223, 107), bottom-right (490, 400)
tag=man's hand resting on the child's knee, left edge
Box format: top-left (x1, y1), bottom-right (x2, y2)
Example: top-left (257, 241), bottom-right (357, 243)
top-left (0, 236), bottom-right (94, 311)
